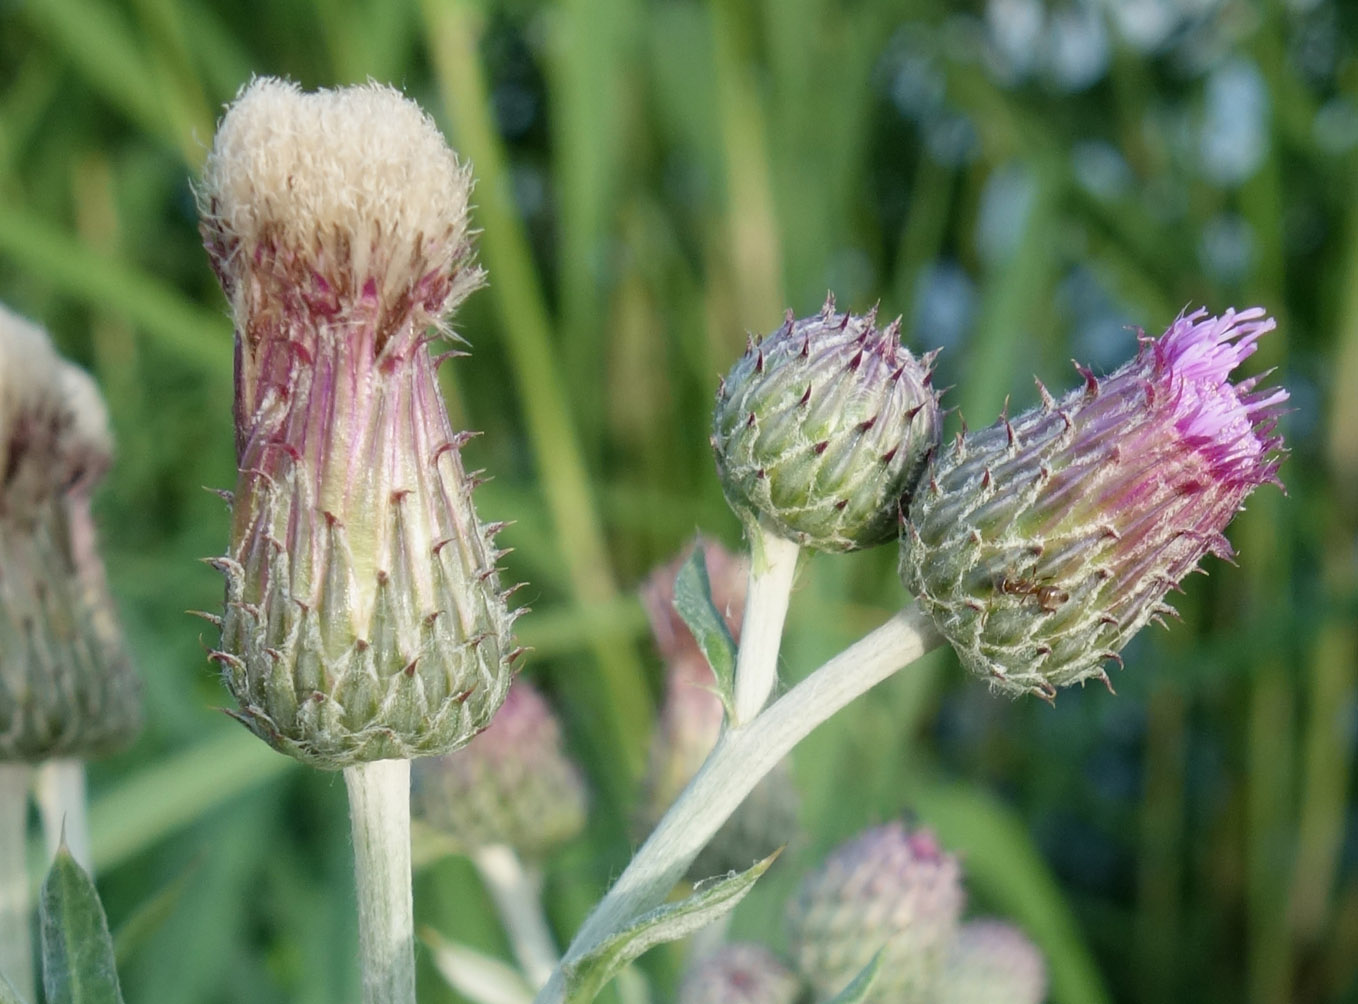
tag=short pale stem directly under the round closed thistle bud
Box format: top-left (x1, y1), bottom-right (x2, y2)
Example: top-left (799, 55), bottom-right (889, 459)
top-left (733, 526), bottom-right (801, 725)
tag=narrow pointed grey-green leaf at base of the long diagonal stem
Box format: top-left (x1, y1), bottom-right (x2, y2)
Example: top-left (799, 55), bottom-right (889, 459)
top-left (562, 848), bottom-right (782, 1004)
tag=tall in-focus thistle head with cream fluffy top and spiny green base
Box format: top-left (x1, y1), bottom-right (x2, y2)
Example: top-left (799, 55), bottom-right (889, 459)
top-left (198, 79), bottom-right (516, 769)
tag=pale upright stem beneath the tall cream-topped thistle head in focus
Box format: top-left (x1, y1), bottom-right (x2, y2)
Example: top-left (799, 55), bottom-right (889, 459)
top-left (344, 759), bottom-right (416, 1004)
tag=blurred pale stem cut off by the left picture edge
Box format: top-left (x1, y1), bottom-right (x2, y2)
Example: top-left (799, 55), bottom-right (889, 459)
top-left (0, 764), bottom-right (38, 1000)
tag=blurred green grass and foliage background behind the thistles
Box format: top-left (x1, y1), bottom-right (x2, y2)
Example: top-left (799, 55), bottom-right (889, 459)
top-left (0, 0), bottom-right (1358, 1004)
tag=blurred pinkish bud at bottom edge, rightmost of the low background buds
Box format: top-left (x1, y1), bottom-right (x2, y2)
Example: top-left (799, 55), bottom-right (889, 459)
top-left (930, 920), bottom-right (1047, 1004)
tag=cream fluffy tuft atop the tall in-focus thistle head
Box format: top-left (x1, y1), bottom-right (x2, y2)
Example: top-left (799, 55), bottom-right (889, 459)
top-left (198, 77), bottom-right (481, 340)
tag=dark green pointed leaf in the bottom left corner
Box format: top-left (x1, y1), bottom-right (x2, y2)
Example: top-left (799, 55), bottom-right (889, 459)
top-left (38, 844), bottom-right (122, 1004)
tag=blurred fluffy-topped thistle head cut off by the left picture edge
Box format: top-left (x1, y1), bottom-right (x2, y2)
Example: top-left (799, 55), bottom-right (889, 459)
top-left (0, 308), bottom-right (141, 762)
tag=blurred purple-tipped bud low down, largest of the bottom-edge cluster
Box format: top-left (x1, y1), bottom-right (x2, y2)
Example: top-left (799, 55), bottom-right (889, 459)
top-left (788, 822), bottom-right (964, 1004)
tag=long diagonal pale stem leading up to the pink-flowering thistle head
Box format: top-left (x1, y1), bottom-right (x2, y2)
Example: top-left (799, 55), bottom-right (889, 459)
top-left (536, 605), bottom-right (942, 1004)
